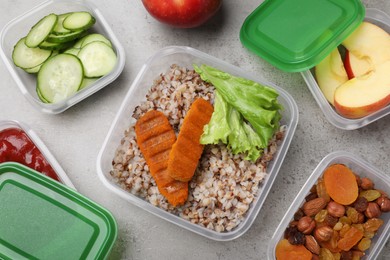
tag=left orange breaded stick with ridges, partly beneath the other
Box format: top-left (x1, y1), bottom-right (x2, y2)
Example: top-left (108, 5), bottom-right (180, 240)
top-left (135, 110), bottom-right (188, 206)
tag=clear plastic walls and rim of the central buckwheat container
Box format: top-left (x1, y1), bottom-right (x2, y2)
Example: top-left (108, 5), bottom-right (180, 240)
top-left (97, 47), bottom-right (298, 241)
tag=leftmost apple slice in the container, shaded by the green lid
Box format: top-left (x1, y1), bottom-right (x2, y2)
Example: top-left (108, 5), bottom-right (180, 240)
top-left (315, 48), bottom-right (348, 105)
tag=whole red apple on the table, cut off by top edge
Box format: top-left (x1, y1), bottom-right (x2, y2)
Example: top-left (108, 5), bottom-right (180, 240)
top-left (142, 0), bottom-right (222, 28)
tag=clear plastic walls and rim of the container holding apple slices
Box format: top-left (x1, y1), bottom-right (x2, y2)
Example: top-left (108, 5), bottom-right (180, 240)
top-left (301, 8), bottom-right (390, 130)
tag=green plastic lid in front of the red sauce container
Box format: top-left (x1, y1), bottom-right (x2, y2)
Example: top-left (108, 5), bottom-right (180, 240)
top-left (0, 163), bottom-right (117, 259)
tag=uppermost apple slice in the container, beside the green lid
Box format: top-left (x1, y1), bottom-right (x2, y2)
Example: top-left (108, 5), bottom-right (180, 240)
top-left (342, 22), bottom-right (390, 68)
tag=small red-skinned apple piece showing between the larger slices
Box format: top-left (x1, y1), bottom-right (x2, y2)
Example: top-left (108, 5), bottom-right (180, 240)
top-left (344, 50), bottom-right (374, 79)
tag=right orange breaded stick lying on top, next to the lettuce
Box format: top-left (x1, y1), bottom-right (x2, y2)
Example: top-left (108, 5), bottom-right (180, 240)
top-left (168, 98), bottom-right (214, 181)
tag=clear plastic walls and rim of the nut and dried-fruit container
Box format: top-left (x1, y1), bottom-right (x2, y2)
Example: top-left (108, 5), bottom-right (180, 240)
top-left (267, 151), bottom-right (390, 260)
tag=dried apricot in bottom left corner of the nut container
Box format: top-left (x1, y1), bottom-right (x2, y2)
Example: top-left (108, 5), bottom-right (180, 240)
top-left (275, 239), bottom-right (313, 260)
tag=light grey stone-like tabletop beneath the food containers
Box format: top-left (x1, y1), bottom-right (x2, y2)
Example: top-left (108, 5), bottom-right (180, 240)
top-left (0, 0), bottom-right (390, 259)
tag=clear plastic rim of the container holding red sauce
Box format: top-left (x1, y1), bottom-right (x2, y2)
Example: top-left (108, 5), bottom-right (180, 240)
top-left (0, 120), bottom-right (75, 189)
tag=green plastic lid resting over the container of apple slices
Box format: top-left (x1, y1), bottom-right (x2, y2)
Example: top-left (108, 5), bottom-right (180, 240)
top-left (240, 0), bottom-right (365, 72)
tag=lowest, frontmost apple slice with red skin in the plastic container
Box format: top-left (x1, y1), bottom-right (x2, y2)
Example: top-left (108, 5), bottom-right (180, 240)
top-left (334, 60), bottom-right (390, 118)
